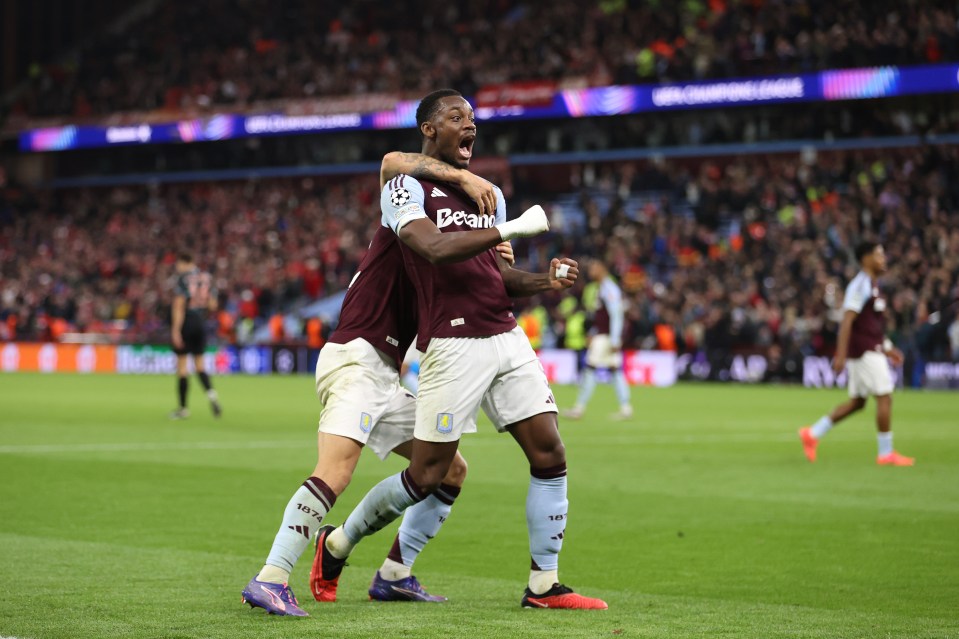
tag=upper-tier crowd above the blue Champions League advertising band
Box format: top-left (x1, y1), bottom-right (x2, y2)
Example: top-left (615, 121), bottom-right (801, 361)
top-left (16, 0), bottom-right (959, 118)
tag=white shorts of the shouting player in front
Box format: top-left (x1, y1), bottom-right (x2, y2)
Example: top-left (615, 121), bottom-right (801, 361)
top-left (414, 327), bottom-right (557, 442)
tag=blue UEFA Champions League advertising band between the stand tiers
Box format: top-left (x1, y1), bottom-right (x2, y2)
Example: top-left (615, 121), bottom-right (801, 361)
top-left (20, 64), bottom-right (959, 151)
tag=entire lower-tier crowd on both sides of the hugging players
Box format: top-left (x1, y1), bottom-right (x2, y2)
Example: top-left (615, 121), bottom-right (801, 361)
top-left (0, 146), bottom-right (959, 358)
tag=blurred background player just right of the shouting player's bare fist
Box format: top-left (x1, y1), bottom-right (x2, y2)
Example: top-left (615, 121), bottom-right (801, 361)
top-left (565, 260), bottom-right (633, 419)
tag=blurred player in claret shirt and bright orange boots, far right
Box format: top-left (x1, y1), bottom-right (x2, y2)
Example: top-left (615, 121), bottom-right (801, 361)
top-left (799, 242), bottom-right (915, 466)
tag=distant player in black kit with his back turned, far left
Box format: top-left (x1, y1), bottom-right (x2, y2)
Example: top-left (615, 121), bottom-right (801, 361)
top-left (170, 253), bottom-right (223, 419)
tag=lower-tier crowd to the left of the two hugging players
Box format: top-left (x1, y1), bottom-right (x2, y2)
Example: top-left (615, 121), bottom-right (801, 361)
top-left (0, 176), bottom-right (378, 341)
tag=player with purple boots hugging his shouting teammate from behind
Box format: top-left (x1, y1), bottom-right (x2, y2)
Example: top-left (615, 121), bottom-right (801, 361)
top-left (243, 154), bottom-right (546, 616)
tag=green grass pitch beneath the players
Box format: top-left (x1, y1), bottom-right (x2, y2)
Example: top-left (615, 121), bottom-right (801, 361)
top-left (0, 374), bottom-right (959, 639)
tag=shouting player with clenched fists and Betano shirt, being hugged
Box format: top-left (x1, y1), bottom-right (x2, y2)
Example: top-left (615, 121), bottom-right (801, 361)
top-left (319, 90), bottom-right (607, 609)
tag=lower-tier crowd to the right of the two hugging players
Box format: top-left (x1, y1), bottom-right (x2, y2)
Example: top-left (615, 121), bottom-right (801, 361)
top-left (516, 146), bottom-right (959, 359)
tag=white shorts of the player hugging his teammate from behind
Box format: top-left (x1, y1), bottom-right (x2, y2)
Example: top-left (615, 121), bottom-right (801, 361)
top-left (316, 338), bottom-right (416, 459)
